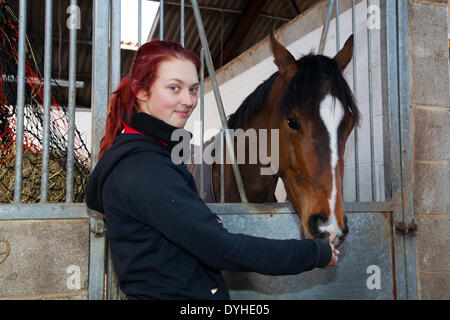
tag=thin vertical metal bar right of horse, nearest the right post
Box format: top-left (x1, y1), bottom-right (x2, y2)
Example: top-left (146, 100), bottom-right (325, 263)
top-left (367, 0), bottom-right (377, 201)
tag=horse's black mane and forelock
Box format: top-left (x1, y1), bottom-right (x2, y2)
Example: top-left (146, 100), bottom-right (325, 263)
top-left (228, 54), bottom-right (360, 129)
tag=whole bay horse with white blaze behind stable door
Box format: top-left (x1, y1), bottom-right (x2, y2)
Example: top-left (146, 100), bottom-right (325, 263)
top-left (191, 33), bottom-right (360, 246)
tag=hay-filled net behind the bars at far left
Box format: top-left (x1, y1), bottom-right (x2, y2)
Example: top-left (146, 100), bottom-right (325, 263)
top-left (0, 0), bottom-right (90, 203)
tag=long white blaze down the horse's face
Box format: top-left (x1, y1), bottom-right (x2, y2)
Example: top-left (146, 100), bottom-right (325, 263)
top-left (319, 94), bottom-right (344, 241)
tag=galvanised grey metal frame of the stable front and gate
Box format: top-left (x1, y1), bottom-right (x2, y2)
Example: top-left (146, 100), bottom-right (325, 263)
top-left (0, 0), bottom-right (418, 300)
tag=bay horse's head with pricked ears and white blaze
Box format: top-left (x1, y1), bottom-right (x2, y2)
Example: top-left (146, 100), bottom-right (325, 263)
top-left (269, 35), bottom-right (359, 246)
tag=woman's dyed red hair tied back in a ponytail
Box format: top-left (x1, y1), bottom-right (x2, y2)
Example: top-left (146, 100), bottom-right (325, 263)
top-left (98, 40), bottom-right (200, 159)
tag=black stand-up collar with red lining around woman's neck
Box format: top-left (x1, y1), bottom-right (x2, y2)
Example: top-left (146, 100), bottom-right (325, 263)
top-left (122, 112), bottom-right (192, 150)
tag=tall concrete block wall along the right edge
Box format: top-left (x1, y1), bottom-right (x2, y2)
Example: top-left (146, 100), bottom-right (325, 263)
top-left (409, 0), bottom-right (450, 300)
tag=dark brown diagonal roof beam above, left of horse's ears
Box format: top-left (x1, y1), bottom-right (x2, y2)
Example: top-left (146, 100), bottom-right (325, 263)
top-left (214, 0), bottom-right (267, 68)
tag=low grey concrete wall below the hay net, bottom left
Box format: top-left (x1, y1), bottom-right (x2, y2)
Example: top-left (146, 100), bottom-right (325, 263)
top-left (0, 219), bottom-right (89, 300)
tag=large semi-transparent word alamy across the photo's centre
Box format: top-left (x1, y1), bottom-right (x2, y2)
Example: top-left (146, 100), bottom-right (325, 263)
top-left (171, 126), bottom-right (279, 175)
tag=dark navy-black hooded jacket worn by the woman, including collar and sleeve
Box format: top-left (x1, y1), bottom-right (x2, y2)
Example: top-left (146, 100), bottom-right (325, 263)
top-left (86, 113), bottom-right (331, 299)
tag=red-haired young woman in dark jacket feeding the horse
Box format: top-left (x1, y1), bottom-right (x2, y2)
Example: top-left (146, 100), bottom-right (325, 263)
top-left (86, 41), bottom-right (338, 299)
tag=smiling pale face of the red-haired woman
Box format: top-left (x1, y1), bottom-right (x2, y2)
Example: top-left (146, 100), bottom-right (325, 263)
top-left (137, 59), bottom-right (200, 128)
